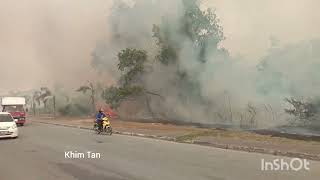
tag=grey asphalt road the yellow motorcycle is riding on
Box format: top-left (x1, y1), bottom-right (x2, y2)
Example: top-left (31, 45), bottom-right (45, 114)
top-left (0, 123), bottom-right (320, 180)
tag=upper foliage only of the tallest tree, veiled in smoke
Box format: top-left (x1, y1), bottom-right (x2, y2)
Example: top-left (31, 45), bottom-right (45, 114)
top-left (152, 0), bottom-right (225, 65)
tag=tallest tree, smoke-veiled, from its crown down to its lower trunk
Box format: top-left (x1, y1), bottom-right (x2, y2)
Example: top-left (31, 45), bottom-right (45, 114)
top-left (152, 0), bottom-right (228, 103)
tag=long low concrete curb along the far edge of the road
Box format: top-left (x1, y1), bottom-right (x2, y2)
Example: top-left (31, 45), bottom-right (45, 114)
top-left (33, 120), bottom-right (320, 161)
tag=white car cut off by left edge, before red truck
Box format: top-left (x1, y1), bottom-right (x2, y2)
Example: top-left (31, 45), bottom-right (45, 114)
top-left (0, 112), bottom-right (19, 138)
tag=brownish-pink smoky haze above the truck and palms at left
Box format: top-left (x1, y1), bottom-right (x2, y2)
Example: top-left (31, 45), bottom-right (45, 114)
top-left (0, 0), bottom-right (111, 90)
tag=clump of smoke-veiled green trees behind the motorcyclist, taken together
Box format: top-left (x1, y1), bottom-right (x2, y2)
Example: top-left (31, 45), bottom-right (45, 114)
top-left (103, 0), bottom-right (224, 116)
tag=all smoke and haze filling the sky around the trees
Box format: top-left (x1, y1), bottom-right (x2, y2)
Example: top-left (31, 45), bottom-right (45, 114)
top-left (0, 0), bottom-right (320, 126)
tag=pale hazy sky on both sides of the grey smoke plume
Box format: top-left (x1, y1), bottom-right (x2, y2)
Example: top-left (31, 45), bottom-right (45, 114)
top-left (0, 0), bottom-right (320, 89)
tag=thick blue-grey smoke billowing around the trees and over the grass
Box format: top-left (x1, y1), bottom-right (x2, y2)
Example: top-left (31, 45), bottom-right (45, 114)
top-left (93, 0), bottom-right (319, 127)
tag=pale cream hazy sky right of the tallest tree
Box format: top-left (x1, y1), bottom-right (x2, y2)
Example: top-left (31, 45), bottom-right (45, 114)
top-left (203, 0), bottom-right (320, 60)
